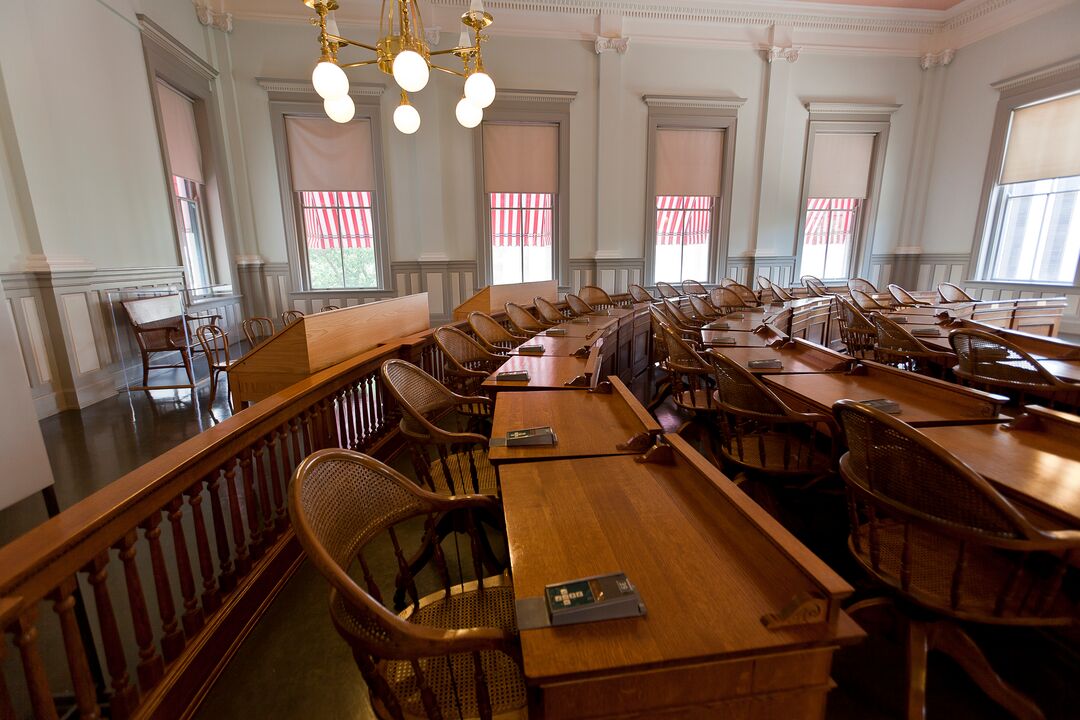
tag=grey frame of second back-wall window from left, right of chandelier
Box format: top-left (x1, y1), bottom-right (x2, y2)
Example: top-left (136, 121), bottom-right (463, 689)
top-left (474, 90), bottom-right (577, 287)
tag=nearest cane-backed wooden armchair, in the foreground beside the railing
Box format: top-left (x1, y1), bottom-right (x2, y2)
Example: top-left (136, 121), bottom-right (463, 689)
top-left (288, 449), bottom-right (527, 720)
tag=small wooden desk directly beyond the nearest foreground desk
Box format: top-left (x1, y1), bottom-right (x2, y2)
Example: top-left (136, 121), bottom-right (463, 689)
top-left (488, 378), bottom-right (663, 464)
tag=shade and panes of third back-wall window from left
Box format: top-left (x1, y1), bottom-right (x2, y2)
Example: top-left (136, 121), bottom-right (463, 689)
top-left (652, 127), bottom-right (725, 283)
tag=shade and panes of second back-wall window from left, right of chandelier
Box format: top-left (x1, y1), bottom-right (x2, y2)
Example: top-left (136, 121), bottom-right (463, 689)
top-left (483, 122), bottom-right (558, 285)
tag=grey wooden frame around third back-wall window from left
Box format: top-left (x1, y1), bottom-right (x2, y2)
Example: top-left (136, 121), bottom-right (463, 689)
top-left (643, 95), bottom-right (746, 285)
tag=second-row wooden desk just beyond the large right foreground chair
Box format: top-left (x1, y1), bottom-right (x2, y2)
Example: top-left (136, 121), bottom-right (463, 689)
top-left (762, 361), bottom-right (1009, 427)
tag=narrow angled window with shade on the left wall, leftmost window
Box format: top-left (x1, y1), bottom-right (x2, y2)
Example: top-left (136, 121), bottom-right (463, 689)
top-left (157, 80), bottom-right (215, 296)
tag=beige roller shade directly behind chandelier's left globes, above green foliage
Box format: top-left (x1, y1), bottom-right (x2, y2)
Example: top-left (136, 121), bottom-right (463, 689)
top-left (285, 118), bottom-right (375, 192)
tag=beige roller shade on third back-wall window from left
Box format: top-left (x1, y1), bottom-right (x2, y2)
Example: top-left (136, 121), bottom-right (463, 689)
top-left (656, 128), bottom-right (724, 198)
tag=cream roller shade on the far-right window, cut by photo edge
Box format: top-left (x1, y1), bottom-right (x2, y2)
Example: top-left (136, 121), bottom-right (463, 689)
top-left (1001, 93), bottom-right (1080, 185)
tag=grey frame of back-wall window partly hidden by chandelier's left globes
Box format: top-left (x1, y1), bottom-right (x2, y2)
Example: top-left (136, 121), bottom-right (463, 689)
top-left (268, 88), bottom-right (393, 297)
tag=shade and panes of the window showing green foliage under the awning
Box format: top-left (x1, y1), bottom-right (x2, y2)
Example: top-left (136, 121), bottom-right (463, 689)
top-left (285, 117), bottom-right (379, 290)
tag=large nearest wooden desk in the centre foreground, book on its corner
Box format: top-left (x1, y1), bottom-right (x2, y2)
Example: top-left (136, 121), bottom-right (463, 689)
top-left (500, 435), bottom-right (862, 720)
